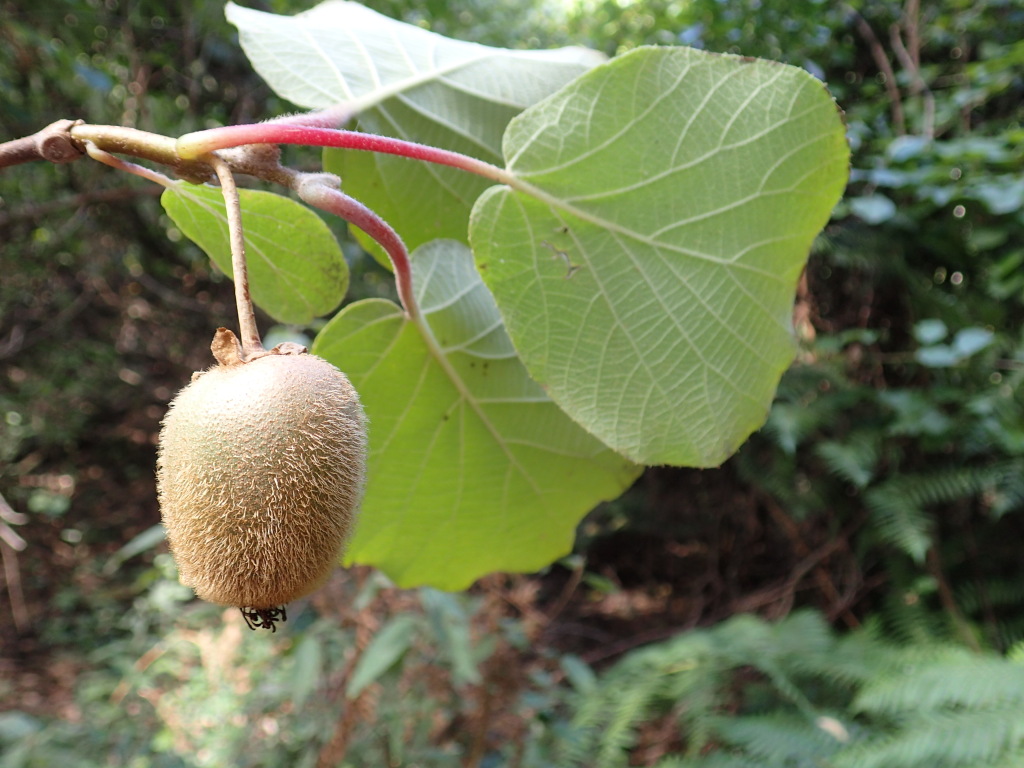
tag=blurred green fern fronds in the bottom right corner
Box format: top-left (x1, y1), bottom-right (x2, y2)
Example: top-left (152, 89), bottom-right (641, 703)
top-left (560, 606), bottom-right (1024, 768)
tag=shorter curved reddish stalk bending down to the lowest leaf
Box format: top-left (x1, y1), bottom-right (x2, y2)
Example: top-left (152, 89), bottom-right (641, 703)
top-left (294, 174), bottom-right (420, 319)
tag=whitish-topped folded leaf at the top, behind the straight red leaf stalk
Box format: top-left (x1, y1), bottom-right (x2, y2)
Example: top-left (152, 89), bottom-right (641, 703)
top-left (226, 0), bottom-right (603, 256)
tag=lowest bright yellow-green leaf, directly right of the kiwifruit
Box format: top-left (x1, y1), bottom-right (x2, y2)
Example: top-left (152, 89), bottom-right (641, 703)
top-left (313, 242), bottom-right (639, 589)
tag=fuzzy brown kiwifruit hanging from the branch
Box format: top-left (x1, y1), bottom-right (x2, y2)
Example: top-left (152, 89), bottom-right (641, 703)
top-left (157, 329), bottom-right (367, 621)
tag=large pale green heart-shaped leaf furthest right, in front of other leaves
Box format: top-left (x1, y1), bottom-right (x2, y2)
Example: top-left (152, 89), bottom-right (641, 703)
top-left (470, 48), bottom-right (849, 466)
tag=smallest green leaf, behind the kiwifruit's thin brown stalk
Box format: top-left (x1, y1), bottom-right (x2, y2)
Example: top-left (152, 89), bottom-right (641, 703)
top-left (160, 181), bottom-right (348, 325)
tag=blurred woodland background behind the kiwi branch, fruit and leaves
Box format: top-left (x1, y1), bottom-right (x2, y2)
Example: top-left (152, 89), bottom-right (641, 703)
top-left (0, 0), bottom-right (1024, 766)
